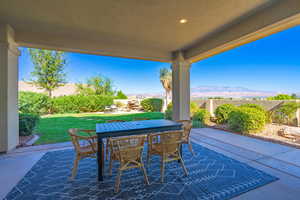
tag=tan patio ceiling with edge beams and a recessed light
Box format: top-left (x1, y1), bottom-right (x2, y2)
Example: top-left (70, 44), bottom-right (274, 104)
top-left (0, 0), bottom-right (300, 62)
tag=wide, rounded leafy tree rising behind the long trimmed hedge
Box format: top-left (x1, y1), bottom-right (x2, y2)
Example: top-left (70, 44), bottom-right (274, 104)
top-left (77, 75), bottom-right (115, 96)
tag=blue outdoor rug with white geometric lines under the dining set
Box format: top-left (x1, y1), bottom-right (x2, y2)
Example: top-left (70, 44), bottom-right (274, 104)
top-left (6, 144), bottom-right (278, 200)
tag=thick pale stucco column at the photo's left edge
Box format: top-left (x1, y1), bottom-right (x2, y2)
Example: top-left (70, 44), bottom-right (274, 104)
top-left (0, 24), bottom-right (20, 152)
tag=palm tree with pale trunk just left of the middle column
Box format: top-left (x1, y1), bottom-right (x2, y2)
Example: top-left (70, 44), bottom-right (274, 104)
top-left (159, 68), bottom-right (172, 111)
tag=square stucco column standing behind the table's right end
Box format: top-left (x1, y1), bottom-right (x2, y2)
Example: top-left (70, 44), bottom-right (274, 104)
top-left (172, 53), bottom-right (191, 120)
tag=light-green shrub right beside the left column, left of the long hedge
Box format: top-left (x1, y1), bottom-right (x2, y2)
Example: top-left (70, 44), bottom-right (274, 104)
top-left (19, 92), bottom-right (50, 115)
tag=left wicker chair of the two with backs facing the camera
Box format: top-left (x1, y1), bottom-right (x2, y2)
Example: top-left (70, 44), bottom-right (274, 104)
top-left (109, 135), bottom-right (149, 192)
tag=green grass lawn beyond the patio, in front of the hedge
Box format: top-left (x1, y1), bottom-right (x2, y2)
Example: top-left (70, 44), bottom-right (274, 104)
top-left (35, 112), bottom-right (164, 144)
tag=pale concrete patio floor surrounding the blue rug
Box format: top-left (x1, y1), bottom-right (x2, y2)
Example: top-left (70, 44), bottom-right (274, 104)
top-left (0, 128), bottom-right (300, 200)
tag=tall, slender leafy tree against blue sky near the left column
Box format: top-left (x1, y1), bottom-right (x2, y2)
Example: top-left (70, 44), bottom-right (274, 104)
top-left (29, 49), bottom-right (66, 97)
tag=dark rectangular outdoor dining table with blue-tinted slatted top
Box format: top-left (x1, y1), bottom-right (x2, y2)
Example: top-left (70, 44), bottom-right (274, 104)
top-left (96, 119), bottom-right (182, 181)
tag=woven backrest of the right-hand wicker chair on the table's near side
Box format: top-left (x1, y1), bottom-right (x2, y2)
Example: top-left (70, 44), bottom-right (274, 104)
top-left (149, 131), bottom-right (183, 154)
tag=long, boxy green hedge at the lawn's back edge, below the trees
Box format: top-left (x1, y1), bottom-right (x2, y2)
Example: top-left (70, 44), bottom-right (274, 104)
top-left (52, 95), bottom-right (113, 113)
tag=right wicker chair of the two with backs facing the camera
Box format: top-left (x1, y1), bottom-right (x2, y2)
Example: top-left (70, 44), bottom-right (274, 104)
top-left (147, 131), bottom-right (188, 183)
